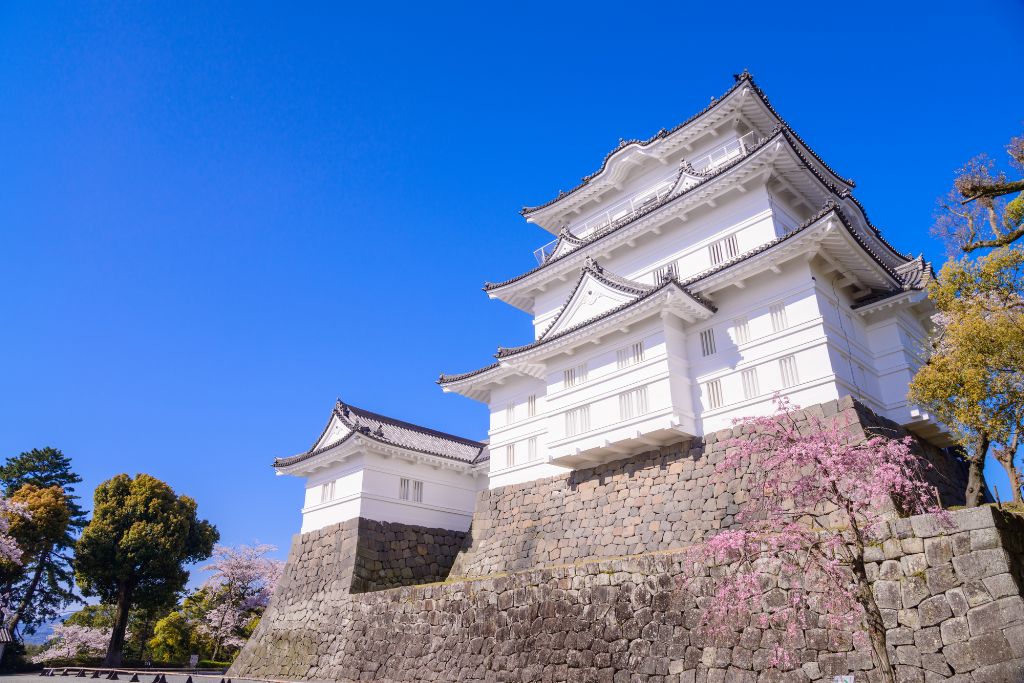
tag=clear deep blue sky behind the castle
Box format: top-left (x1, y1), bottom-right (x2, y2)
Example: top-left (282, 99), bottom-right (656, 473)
top-left (0, 2), bottom-right (1024, 573)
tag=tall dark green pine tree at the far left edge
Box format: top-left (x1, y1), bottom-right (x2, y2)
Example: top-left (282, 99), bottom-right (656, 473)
top-left (0, 447), bottom-right (85, 651)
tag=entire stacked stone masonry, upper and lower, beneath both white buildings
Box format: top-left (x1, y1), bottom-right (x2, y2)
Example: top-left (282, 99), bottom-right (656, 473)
top-left (230, 401), bottom-right (1003, 683)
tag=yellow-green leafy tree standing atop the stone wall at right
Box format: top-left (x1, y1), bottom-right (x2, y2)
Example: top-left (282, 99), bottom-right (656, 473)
top-left (909, 247), bottom-right (1024, 506)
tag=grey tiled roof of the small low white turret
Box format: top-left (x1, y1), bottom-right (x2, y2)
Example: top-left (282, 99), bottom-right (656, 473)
top-left (273, 400), bottom-right (486, 467)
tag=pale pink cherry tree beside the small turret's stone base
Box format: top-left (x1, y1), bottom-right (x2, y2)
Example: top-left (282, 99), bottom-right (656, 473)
top-left (199, 544), bottom-right (284, 659)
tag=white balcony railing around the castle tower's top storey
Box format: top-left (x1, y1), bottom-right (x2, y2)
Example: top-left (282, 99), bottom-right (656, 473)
top-left (534, 130), bottom-right (759, 265)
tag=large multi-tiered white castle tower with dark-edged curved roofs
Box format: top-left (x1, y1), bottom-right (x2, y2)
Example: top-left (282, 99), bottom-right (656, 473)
top-left (438, 72), bottom-right (948, 488)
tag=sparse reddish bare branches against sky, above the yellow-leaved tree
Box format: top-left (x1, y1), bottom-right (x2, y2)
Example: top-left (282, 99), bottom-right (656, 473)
top-left (934, 136), bottom-right (1024, 253)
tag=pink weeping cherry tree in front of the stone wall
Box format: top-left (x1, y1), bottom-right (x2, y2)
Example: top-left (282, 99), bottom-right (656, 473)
top-left (688, 397), bottom-right (944, 682)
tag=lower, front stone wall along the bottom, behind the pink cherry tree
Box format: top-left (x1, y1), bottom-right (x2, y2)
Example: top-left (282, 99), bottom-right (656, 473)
top-left (229, 507), bottom-right (1024, 683)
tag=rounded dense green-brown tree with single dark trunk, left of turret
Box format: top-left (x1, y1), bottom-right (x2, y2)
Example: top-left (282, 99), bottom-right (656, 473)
top-left (75, 474), bottom-right (220, 666)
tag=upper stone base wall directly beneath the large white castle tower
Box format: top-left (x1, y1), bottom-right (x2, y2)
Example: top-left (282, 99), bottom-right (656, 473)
top-left (452, 397), bottom-right (967, 577)
